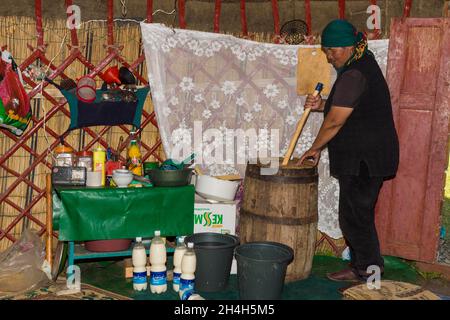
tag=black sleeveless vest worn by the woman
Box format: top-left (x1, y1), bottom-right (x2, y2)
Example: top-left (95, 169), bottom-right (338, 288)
top-left (324, 55), bottom-right (399, 177)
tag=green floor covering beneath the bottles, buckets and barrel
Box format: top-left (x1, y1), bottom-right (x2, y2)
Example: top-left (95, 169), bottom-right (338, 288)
top-left (80, 256), bottom-right (428, 300)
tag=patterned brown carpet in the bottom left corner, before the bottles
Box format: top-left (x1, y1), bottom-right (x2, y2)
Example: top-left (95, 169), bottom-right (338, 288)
top-left (0, 278), bottom-right (132, 300)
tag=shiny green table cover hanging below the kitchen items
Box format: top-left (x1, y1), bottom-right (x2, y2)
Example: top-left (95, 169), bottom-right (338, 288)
top-left (53, 185), bottom-right (195, 241)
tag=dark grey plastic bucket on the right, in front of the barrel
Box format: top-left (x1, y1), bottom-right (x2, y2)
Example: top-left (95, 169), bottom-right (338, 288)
top-left (235, 241), bottom-right (294, 300)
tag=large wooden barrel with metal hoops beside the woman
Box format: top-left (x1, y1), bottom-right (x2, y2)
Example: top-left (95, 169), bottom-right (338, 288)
top-left (239, 160), bottom-right (318, 281)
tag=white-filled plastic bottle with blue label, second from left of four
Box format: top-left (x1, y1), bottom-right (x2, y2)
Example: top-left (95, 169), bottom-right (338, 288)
top-left (150, 230), bottom-right (167, 294)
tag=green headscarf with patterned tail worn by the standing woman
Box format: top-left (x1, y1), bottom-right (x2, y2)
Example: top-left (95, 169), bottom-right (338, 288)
top-left (322, 19), bottom-right (373, 74)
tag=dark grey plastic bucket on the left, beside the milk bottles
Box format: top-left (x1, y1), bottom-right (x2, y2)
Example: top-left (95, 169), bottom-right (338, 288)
top-left (184, 232), bottom-right (239, 292)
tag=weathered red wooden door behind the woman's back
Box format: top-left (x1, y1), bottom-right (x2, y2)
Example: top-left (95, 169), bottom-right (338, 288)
top-left (376, 18), bottom-right (450, 262)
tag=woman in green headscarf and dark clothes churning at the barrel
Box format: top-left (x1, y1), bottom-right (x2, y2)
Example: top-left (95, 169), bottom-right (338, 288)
top-left (299, 20), bottom-right (399, 281)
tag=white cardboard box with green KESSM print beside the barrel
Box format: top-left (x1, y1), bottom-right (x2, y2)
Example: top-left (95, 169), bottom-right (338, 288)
top-left (194, 195), bottom-right (238, 274)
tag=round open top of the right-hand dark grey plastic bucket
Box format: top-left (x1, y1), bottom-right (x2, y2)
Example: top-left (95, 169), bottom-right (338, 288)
top-left (235, 241), bottom-right (294, 264)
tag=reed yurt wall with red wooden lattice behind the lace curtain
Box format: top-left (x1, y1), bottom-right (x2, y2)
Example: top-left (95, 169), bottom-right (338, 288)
top-left (0, 0), bottom-right (448, 254)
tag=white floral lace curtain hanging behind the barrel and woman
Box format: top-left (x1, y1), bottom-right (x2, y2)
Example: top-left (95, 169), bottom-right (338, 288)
top-left (141, 23), bottom-right (388, 239)
